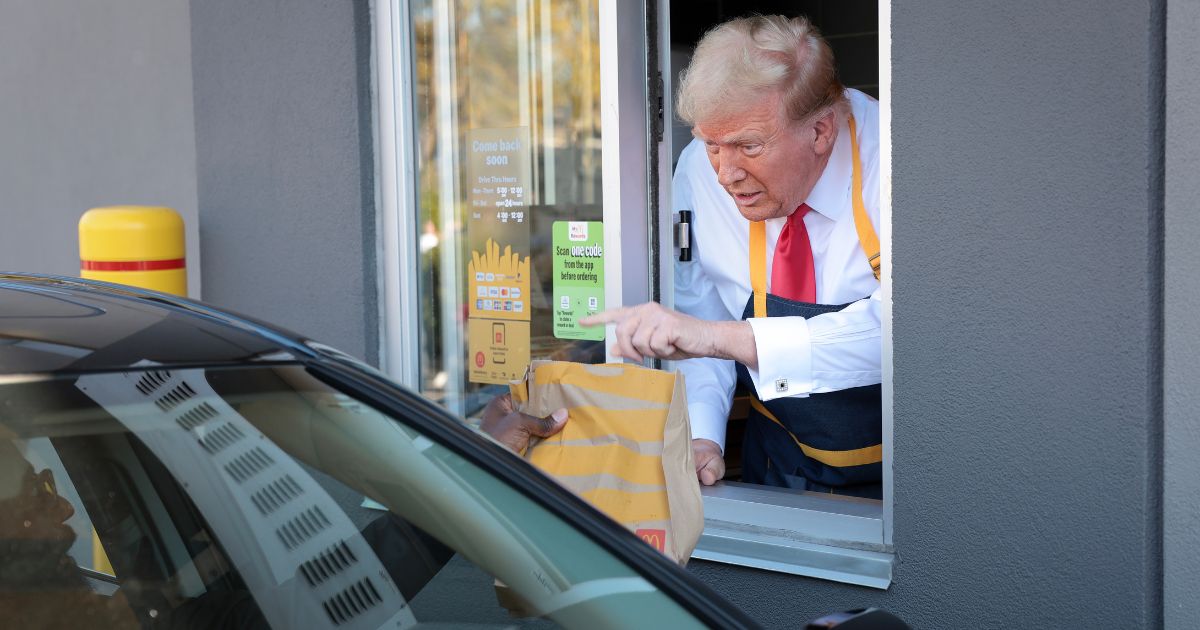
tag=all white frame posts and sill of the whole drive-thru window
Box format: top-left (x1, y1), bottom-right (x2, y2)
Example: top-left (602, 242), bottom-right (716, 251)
top-left (373, 0), bottom-right (894, 588)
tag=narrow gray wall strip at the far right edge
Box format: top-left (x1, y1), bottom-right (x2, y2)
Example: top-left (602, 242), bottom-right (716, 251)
top-left (1163, 0), bottom-right (1200, 630)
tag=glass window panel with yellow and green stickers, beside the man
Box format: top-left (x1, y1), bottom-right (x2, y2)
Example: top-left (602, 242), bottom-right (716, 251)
top-left (377, 0), bottom-right (648, 414)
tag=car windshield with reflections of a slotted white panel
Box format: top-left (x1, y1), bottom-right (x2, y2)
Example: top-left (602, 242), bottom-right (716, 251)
top-left (0, 366), bottom-right (695, 629)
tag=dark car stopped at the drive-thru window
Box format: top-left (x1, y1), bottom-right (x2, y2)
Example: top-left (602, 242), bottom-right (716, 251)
top-left (0, 274), bottom-right (755, 629)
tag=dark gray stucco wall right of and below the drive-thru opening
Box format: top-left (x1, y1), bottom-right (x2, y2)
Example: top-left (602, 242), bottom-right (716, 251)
top-left (692, 0), bottom-right (1166, 628)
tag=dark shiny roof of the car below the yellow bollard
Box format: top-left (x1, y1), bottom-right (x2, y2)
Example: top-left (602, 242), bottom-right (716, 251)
top-left (0, 272), bottom-right (316, 374)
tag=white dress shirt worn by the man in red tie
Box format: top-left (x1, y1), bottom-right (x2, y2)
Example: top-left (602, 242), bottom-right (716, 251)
top-left (673, 90), bottom-right (882, 450)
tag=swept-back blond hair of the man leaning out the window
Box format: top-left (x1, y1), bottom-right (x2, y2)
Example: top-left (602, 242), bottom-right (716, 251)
top-left (676, 16), bottom-right (845, 126)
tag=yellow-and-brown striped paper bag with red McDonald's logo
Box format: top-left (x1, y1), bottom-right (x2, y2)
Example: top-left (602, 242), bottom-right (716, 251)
top-left (510, 361), bottom-right (704, 564)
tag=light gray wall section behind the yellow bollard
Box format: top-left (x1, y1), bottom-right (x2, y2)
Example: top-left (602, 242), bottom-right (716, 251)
top-left (0, 0), bottom-right (200, 296)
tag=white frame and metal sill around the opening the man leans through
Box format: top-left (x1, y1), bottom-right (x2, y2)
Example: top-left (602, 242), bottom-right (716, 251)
top-left (657, 0), bottom-right (895, 589)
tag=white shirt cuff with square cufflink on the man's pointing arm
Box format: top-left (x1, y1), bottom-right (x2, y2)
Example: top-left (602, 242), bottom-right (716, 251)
top-left (746, 317), bottom-right (814, 402)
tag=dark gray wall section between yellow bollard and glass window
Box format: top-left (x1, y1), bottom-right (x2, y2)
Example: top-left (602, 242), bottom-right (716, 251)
top-left (191, 0), bottom-right (378, 364)
